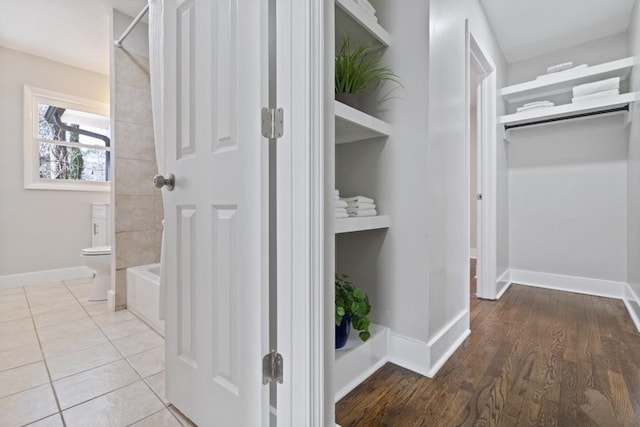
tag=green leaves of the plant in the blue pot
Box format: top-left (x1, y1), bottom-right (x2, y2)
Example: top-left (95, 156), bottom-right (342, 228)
top-left (335, 273), bottom-right (371, 341)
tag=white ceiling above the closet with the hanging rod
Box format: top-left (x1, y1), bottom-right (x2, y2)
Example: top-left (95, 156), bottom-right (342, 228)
top-left (480, 0), bottom-right (635, 63)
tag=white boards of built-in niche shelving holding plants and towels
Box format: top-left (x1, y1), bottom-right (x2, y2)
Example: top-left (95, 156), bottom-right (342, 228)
top-left (334, 0), bottom-right (392, 400)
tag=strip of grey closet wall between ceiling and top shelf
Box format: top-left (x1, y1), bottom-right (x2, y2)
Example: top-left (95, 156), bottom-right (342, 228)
top-left (508, 33), bottom-right (629, 85)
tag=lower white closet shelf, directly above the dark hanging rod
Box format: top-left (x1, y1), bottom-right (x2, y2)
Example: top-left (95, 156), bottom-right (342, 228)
top-left (498, 93), bottom-right (638, 125)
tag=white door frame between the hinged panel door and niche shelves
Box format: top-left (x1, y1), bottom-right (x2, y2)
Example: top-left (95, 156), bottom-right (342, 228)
top-left (275, 0), bottom-right (333, 427)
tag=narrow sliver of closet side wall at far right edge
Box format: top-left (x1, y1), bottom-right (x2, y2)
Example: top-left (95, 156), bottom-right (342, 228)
top-left (627, 2), bottom-right (640, 310)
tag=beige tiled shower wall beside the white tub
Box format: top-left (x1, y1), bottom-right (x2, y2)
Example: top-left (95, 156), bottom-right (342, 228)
top-left (112, 49), bottom-right (164, 310)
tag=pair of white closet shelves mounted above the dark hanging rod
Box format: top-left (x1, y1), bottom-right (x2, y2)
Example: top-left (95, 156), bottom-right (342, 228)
top-left (498, 58), bottom-right (638, 129)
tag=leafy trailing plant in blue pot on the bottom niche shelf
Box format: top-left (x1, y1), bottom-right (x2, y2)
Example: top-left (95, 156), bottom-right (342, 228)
top-left (335, 273), bottom-right (371, 348)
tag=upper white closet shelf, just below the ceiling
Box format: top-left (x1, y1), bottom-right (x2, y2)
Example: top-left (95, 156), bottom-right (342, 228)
top-left (500, 57), bottom-right (634, 104)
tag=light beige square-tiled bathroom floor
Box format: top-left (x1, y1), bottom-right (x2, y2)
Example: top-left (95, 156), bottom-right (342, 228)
top-left (0, 279), bottom-right (193, 427)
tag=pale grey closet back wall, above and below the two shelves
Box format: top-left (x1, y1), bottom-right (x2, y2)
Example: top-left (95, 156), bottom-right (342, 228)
top-left (508, 35), bottom-right (628, 282)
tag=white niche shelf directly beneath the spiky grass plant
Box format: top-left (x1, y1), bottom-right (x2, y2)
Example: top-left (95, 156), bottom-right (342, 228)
top-left (335, 101), bottom-right (391, 144)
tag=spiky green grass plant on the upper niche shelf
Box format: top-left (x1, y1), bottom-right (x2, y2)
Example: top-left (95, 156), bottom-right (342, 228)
top-left (335, 37), bottom-right (400, 108)
